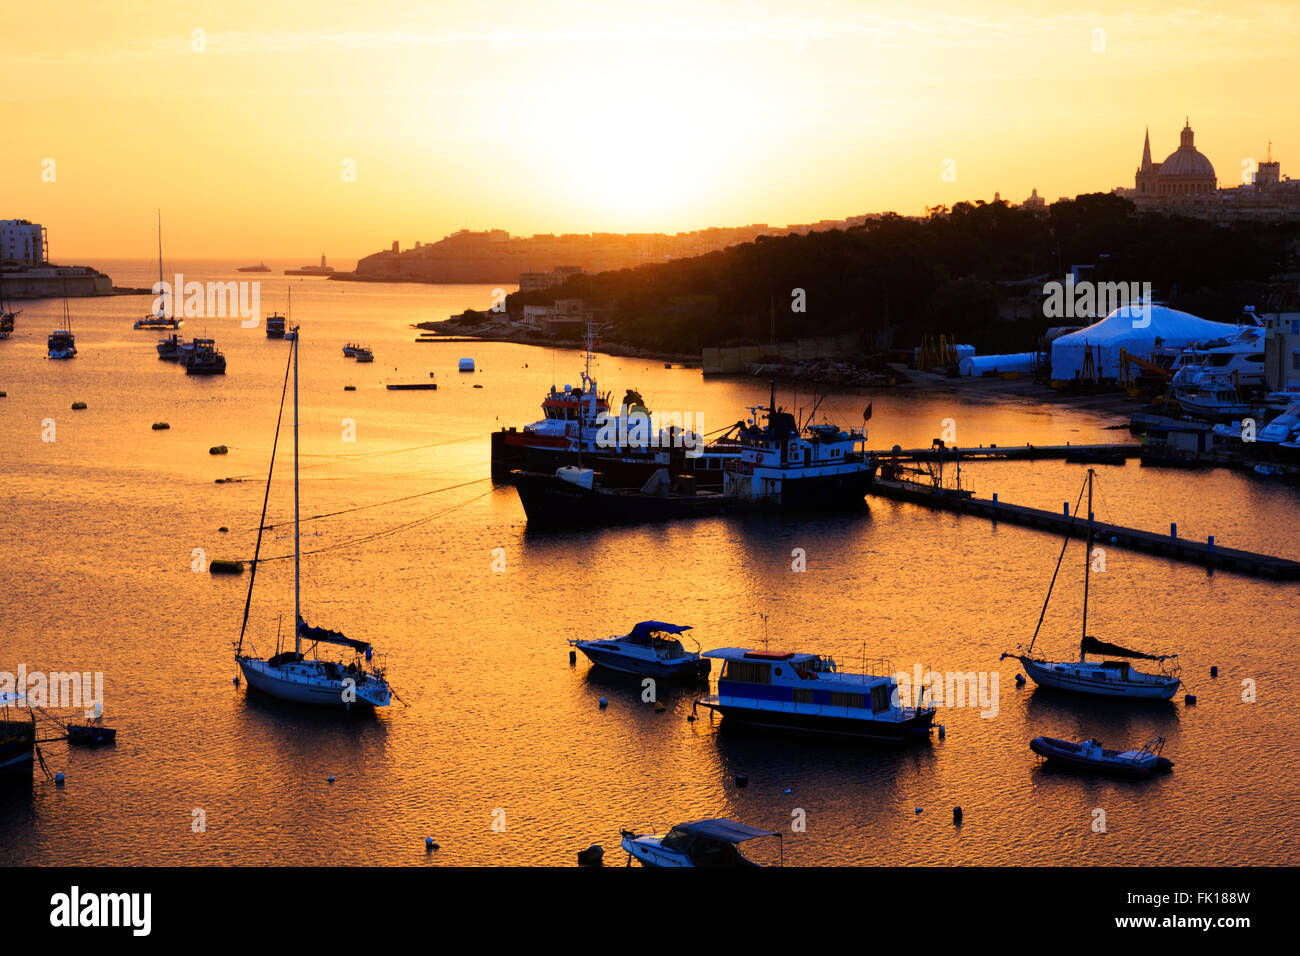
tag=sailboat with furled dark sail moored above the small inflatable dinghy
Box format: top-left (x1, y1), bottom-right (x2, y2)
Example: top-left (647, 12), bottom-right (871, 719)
top-left (998, 468), bottom-right (1182, 700)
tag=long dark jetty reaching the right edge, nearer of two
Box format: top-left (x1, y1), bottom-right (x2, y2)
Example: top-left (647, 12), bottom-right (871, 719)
top-left (867, 477), bottom-right (1300, 580)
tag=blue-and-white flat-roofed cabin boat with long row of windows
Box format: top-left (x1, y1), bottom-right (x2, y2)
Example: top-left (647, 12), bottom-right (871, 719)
top-left (697, 648), bottom-right (935, 743)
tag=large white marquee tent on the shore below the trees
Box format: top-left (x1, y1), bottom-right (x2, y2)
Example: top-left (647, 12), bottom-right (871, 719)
top-left (1052, 306), bottom-right (1238, 381)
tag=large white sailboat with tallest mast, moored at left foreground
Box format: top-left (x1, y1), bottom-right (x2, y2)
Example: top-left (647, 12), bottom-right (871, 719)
top-left (235, 328), bottom-right (393, 709)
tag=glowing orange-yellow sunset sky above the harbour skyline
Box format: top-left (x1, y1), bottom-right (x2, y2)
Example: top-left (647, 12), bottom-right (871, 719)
top-left (0, 0), bottom-right (1300, 267)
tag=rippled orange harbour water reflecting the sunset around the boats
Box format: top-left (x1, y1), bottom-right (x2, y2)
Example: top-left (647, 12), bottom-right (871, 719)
top-left (0, 264), bottom-right (1300, 865)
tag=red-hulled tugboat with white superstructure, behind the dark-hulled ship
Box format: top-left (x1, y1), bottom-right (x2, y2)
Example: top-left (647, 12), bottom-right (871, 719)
top-left (491, 323), bottom-right (740, 488)
